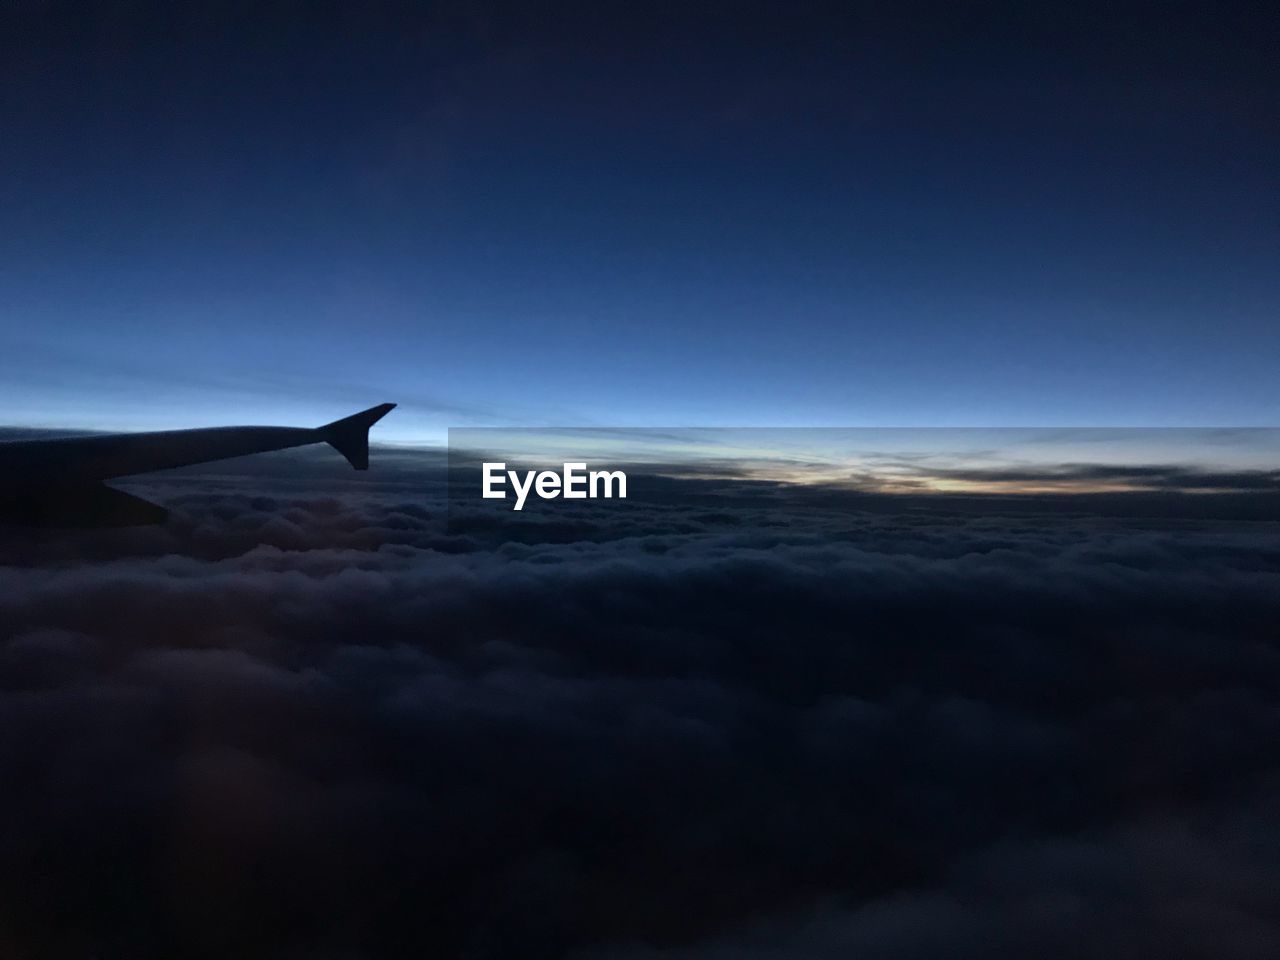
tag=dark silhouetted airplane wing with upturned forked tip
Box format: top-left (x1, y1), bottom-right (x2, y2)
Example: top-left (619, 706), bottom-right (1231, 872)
top-left (0, 403), bottom-right (396, 526)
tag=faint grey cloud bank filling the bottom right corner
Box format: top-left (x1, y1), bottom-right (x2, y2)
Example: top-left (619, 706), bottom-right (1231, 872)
top-left (580, 785), bottom-right (1280, 960)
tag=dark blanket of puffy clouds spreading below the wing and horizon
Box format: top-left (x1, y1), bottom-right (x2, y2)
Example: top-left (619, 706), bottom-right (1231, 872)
top-left (0, 458), bottom-right (1280, 957)
